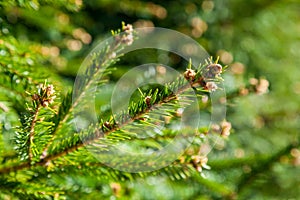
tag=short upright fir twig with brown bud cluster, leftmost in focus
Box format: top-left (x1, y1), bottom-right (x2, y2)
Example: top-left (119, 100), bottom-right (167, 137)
top-left (14, 82), bottom-right (56, 162)
